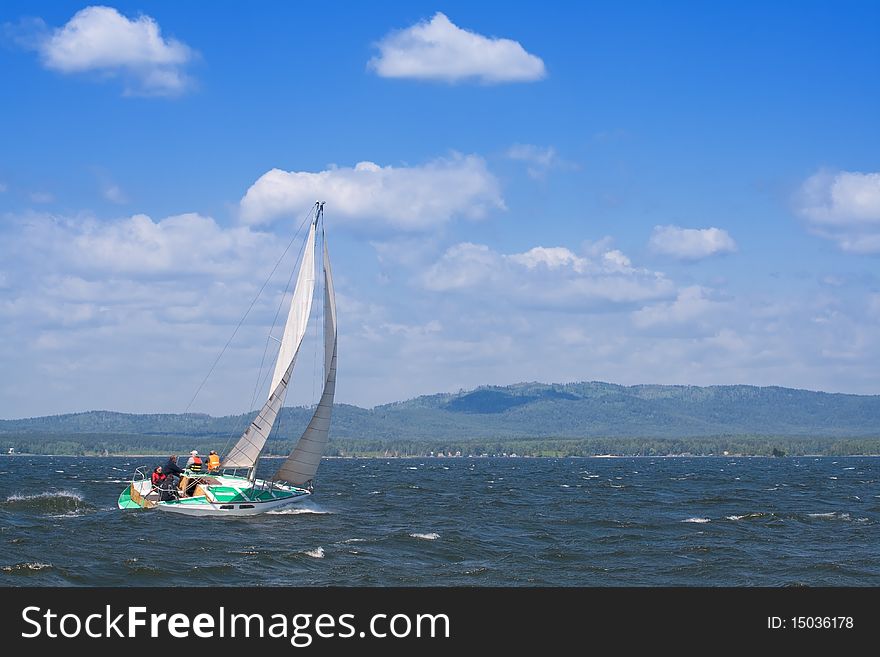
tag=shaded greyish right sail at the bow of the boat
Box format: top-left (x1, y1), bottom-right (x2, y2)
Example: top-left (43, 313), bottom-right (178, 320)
top-left (272, 241), bottom-right (336, 486)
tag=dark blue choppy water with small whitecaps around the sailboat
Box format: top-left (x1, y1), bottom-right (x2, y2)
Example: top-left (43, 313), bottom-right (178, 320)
top-left (0, 456), bottom-right (880, 586)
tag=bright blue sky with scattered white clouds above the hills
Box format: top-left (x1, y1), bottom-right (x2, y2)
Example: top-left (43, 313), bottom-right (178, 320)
top-left (0, 2), bottom-right (880, 417)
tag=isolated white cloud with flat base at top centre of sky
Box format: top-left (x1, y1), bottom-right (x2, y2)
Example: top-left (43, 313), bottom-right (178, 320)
top-left (368, 12), bottom-right (546, 84)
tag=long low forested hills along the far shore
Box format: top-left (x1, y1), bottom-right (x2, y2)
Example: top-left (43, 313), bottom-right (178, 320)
top-left (0, 382), bottom-right (880, 442)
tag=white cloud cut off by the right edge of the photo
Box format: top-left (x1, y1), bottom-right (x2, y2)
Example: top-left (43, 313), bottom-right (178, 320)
top-left (794, 170), bottom-right (880, 253)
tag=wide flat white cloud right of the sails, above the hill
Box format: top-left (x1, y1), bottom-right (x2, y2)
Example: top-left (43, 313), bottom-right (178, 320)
top-left (422, 242), bottom-right (674, 310)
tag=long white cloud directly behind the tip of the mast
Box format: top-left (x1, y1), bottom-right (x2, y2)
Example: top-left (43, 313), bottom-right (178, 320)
top-left (241, 154), bottom-right (504, 230)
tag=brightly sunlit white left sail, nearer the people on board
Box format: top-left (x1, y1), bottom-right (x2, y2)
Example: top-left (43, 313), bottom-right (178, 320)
top-left (221, 216), bottom-right (318, 468)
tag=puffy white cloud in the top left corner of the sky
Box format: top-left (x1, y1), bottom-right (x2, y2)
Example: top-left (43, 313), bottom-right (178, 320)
top-left (36, 6), bottom-right (194, 95)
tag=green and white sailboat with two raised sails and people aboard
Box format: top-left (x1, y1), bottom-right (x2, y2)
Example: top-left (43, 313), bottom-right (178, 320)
top-left (118, 202), bottom-right (337, 516)
